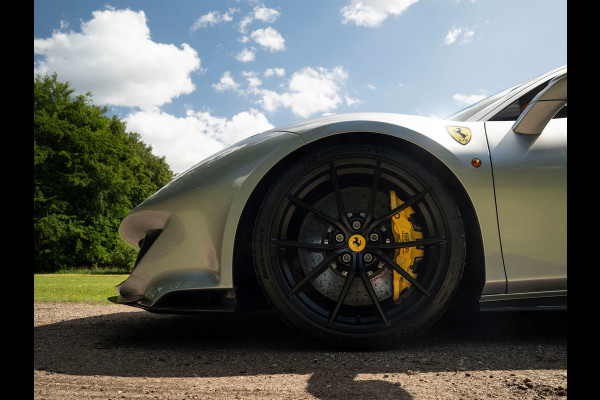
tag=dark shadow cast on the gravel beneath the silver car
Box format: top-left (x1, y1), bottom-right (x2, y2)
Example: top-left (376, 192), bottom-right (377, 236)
top-left (34, 311), bottom-right (567, 399)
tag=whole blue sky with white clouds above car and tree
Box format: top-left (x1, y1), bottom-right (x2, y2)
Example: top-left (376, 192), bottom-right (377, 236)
top-left (34, 0), bottom-right (567, 172)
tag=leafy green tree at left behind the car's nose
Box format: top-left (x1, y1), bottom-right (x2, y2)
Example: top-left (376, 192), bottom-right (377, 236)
top-left (33, 73), bottom-right (173, 272)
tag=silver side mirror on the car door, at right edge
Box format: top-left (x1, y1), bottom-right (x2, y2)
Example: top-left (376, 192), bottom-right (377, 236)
top-left (512, 74), bottom-right (567, 135)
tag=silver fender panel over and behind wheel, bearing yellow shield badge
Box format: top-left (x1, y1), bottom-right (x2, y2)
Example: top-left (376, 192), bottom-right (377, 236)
top-left (279, 113), bottom-right (506, 294)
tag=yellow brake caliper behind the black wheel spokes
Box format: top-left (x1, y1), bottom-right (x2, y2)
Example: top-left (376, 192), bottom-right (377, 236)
top-left (390, 190), bottom-right (423, 300)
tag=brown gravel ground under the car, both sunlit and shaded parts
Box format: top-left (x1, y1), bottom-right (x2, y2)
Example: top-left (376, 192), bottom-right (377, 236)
top-left (33, 303), bottom-right (567, 400)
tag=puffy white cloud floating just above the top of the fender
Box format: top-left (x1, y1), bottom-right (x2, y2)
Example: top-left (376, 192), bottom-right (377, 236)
top-left (255, 67), bottom-right (356, 117)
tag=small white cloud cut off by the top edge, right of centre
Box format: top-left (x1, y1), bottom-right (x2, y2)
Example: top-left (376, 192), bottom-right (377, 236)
top-left (340, 0), bottom-right (419, 28)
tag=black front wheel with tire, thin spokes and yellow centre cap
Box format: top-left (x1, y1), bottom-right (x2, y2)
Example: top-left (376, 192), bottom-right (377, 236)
top-left (253, 145), bottom-right (465, 348)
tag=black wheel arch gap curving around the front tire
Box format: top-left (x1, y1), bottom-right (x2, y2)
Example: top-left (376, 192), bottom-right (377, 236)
top-left (232, 132), bottom-right (485, 310)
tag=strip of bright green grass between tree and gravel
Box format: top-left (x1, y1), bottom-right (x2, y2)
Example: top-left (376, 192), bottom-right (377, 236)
top-left (33, 273), bottom-right (129, 304)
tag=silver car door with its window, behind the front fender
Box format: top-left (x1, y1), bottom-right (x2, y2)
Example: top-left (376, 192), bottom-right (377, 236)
top-left (485, 76), bottom-right (567, 294)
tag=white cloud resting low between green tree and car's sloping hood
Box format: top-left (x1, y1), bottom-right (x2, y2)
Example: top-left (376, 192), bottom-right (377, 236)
top-left (124, 108), bottom-right (273, 173)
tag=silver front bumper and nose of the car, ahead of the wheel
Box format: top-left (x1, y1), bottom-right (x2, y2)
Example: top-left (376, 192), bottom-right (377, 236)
top-left (115, 131), bottom-right (304, 310)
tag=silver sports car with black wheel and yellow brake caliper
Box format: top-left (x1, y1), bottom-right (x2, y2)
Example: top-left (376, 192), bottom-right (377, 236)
top-left (113, 66), bottom-right (567, 346)
